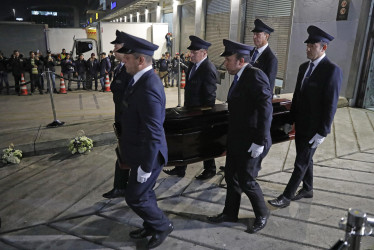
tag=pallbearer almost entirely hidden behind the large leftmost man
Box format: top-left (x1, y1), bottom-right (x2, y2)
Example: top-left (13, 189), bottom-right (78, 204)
top-left (103, 30), bottom-right (132, 199)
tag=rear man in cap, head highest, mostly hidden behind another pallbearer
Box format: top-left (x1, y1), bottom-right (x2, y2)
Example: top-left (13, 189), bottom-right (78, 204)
top-left (251, 19), bottom-right (278, 93)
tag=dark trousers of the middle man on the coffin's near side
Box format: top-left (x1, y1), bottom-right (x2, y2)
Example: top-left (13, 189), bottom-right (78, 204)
top-left (223, 145), bottom-right (269, 218)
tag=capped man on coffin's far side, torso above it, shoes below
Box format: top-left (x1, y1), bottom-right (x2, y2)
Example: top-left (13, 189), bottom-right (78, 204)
top-left (164, 36), bottom-right (217, 180)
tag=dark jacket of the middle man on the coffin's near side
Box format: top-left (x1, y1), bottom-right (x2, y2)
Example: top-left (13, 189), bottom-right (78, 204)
top-left (227, 64), bottom-right (273, 153)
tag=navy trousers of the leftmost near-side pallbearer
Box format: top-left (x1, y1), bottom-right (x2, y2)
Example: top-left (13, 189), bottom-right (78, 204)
top-left (125, 156), bottom-right (170, 231)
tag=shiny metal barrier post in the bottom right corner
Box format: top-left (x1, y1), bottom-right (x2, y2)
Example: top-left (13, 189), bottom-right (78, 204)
top-left (330, 208), bottom-right (374, 250)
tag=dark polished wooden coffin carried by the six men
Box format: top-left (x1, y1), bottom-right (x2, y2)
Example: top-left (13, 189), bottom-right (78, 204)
top-left (164, 99), bottom-right (294, 166)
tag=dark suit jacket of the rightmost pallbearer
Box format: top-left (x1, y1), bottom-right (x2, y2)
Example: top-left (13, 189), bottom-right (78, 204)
top-left (291, 56), bottom-right (343, 139)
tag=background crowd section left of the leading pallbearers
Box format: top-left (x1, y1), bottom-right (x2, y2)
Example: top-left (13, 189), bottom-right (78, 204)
top-left (0, 49), bottom-right (117, 95)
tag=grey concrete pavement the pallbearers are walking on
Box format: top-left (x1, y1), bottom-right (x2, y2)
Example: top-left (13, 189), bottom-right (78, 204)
top-left (0, 85), bottom-right (374, 249)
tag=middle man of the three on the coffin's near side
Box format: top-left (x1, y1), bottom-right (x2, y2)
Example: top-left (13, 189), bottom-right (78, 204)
top-left (208, 39), bottom-right (273, 233)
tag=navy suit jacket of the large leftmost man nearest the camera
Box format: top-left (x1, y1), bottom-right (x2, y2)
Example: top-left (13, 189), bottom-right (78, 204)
top-left (120, 70), bottom-right (168, 173)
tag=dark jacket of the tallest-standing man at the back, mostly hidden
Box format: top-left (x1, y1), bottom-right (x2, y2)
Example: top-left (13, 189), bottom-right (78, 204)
top-left (251, 46), bottom-right (278, 93)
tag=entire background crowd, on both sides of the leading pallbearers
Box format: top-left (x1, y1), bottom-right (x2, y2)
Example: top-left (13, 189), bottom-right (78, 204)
top-left (0, 44), bottom-right (191, 95)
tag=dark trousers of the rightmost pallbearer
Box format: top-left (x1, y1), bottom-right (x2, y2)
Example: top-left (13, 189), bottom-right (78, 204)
top-left (283, 133), bottom-right (317, 199)
